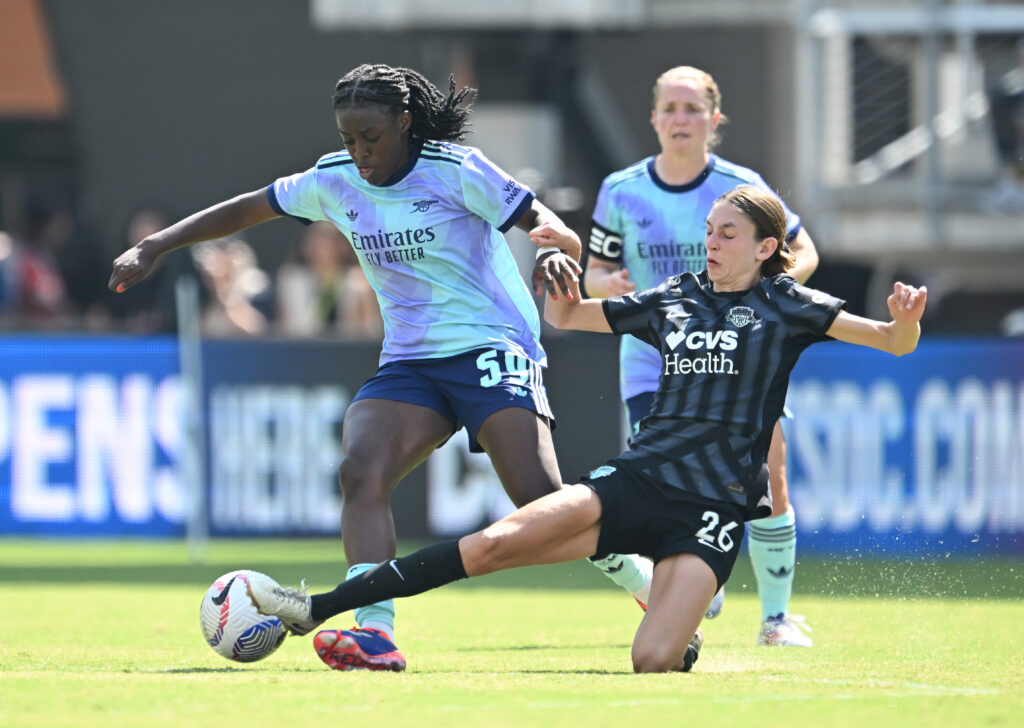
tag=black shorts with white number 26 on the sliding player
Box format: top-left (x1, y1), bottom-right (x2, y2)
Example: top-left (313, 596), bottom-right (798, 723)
top-left (580, 460), bottom-right (746, 588)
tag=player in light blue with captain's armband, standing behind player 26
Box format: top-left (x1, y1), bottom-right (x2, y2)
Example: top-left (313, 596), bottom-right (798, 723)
top-left (584, 66), bottom-right (818, 646)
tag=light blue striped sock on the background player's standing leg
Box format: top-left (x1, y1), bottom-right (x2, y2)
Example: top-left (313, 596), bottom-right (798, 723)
top-left (746, 506), bottom-right (797, 622)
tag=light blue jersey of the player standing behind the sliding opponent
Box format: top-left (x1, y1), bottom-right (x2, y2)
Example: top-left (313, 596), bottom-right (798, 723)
top-left (589, 155), bottom-right (801, 400)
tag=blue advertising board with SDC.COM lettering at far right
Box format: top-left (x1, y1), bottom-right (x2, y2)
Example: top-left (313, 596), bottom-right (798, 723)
top-left (786, 339), bottom-right (1024, 554)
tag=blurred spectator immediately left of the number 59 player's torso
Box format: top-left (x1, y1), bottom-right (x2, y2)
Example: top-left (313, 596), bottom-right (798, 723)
top-left (276, 222), bottom-right (384, 339)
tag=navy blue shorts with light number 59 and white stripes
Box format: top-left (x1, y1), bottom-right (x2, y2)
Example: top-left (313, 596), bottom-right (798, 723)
top-left (352, 349), bottom-right (555, 453)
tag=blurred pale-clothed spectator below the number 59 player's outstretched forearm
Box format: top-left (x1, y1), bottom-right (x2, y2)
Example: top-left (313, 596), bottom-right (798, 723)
top-left (191, 238), bottom-right (273, 336)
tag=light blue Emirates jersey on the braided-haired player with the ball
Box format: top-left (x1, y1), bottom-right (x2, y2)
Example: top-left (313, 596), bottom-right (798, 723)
top-left (267, 141), bottom-right (547, 366)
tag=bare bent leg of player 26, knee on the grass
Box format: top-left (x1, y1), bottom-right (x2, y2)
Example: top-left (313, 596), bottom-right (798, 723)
top-left (633, 553), bottom-right (718, 672)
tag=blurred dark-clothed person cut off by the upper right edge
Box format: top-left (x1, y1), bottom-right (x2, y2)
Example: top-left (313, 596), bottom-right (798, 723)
top-left (986, 38), bottom-right (1024, 210)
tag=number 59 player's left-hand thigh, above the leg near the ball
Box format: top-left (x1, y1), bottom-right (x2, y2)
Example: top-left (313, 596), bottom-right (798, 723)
top-left (341, 399), bottom-right (455, 488)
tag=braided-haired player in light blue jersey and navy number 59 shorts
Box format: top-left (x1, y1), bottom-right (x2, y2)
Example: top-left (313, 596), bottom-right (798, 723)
top-left (109, 65), bottom-right (651, 670)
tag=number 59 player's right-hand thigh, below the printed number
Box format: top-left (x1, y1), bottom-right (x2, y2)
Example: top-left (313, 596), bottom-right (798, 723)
top-left (477, 406), bottom-right (562, 506)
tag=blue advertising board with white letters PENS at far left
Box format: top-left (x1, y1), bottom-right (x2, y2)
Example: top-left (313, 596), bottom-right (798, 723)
top-left (0, 337), bottom-right (184, 537)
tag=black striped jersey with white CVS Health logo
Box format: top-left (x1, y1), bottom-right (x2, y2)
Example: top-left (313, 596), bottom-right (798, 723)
top-left (602, 271), bottom-right (846, 518)
